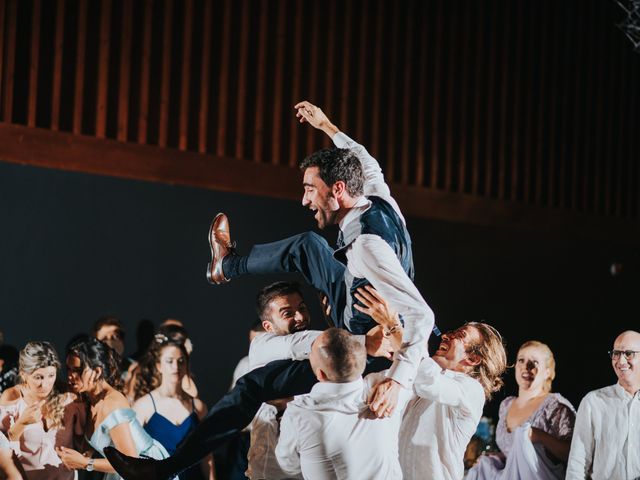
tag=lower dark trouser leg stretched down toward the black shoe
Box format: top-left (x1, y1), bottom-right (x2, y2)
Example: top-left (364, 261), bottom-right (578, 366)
top-left (160, 360), bottom-right (317, 477)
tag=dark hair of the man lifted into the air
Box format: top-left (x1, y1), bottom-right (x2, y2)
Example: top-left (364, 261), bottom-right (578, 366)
top-left (300, 148), bottom-right (364, 197)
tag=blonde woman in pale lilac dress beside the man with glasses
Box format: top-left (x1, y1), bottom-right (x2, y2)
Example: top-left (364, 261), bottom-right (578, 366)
top-left (467, 340), bottom-right (576, 480)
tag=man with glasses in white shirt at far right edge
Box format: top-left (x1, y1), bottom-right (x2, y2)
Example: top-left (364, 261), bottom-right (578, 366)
top-left (566, 330), bottom-right (640, 480)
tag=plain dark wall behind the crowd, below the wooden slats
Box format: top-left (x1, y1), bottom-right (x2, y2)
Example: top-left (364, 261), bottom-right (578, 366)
top-left (0, 163), bottom-right (640, 413)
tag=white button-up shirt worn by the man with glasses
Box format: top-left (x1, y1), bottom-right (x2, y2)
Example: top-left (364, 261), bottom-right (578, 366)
top-left (566, 384), bottom-right (640, 480)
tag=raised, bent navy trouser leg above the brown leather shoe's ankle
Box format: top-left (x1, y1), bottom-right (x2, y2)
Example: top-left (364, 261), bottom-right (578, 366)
top-left (228, 232), bottom-right (346, 325)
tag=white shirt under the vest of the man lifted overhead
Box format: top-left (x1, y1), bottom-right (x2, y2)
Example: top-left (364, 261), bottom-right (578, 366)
top-left (333, 132), bottom-right (434, 388)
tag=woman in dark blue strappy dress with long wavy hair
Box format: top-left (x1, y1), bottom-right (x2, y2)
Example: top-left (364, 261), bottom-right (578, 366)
top-left (133, 332), bottom-right (215, 480)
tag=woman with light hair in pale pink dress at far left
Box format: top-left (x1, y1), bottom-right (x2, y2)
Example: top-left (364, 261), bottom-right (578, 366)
top-left (0, 342), bottom-right (85, 480)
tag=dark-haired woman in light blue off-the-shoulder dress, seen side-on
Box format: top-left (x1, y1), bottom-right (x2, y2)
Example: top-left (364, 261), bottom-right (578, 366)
top-left (58, 338), bottom-right (168, 480)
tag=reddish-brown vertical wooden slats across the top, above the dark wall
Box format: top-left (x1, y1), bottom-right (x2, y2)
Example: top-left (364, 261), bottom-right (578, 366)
top-left (0, 0), bottom-right (640, 242)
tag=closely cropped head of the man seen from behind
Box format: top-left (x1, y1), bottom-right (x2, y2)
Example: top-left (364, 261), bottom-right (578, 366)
top-left (320, 327), bottom-right (367, 383)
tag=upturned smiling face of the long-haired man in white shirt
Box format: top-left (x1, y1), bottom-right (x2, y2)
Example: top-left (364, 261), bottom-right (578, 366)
top-left (433, 325), bottom-right (481, 372)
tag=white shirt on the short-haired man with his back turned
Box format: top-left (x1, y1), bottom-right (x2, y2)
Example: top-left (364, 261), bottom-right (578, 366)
top-left (276, 373), bottom-right (411, 480)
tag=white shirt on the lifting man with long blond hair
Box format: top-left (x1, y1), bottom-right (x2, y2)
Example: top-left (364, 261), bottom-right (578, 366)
top-left (399, 358), bottom-right (485, 480)
